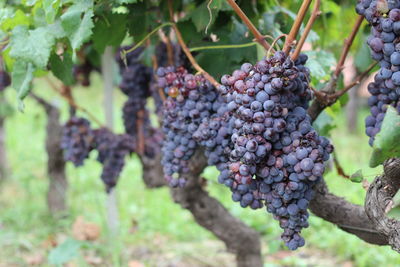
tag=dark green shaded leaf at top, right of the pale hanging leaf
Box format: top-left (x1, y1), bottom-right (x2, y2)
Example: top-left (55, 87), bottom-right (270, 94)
top-left (93, 14), bottom-right (127, 54)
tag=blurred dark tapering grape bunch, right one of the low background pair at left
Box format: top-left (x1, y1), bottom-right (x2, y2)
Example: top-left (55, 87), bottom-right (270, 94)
top-left (93, 128), bottom-right (135, 193)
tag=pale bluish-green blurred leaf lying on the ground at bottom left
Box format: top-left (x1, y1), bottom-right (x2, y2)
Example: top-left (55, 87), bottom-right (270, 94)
top-left (48, 238), bottom-right (83, 265)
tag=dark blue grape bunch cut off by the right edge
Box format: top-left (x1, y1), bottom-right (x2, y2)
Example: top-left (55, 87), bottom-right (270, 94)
top-left (356, 0), bottom-right (400, 146)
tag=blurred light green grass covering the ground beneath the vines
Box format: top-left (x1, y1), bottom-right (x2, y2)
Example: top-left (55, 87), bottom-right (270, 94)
top-left (0, 74), bottom-right (400, 266)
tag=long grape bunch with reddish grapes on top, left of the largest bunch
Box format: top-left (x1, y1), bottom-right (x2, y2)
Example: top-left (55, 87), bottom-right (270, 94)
top-left (157, 67), bottom-right (218, 187)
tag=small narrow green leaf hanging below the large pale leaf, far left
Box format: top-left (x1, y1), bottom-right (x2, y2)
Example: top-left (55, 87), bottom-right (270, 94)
top-left (11, 60), bottom-right (35, 104)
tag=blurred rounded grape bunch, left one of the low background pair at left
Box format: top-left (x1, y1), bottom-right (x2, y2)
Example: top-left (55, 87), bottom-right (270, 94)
top-left (61, 117), bottom-right (93, 167)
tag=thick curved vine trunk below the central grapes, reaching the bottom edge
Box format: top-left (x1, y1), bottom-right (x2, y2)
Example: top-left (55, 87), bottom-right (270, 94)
top-left (141, 151), bottom-right (263, 267)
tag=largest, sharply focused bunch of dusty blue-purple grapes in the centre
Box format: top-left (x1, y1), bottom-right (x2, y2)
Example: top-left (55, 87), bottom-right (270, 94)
top-left (205, 52), bottom-right (333, 250)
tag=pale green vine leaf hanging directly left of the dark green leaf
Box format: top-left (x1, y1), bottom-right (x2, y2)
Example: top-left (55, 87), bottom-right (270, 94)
top-left (61, 4), bottom-right (94, 50)
